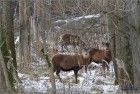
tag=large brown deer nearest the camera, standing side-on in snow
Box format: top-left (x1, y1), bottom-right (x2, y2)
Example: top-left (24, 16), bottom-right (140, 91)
top-left (52, 52), bottom-right (89, 83)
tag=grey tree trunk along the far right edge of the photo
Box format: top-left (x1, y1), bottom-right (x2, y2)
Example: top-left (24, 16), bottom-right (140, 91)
top-left (127, 0), bottom-right (140, 90)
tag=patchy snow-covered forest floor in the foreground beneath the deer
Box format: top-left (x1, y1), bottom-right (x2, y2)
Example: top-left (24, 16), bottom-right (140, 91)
top-left (18, 62), bottom-right (119, 94)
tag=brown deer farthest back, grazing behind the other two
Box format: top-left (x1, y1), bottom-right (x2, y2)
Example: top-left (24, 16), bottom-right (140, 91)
top-left (60, 34), bottom-right (85, 50)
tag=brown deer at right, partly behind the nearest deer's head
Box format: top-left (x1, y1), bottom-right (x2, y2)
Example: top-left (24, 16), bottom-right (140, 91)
top-left (89, 48), bottom-right (112, 70)
